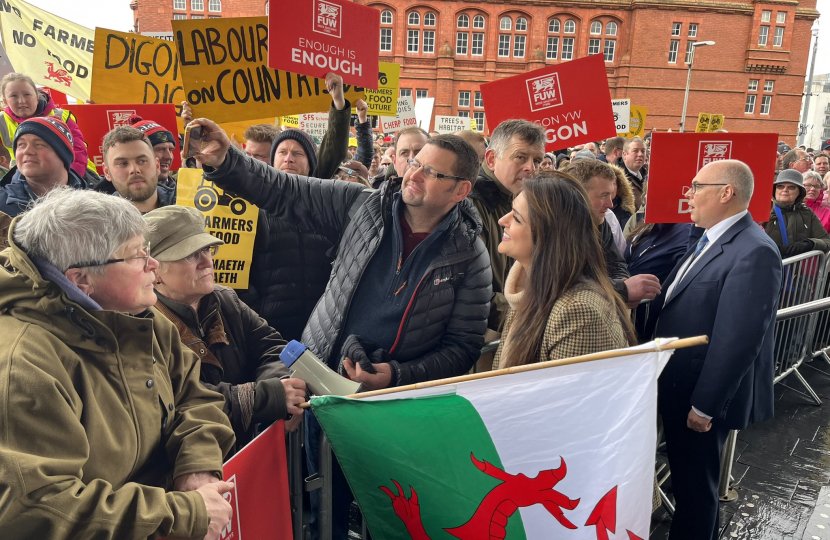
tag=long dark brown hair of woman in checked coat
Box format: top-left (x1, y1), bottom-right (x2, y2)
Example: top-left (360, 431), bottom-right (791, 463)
top-left (503, 170), bottom-right (637, 367)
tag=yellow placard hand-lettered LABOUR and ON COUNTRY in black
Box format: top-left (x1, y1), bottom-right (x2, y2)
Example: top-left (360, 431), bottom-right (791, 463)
top-left (173, 17), bottom-right (364, 123)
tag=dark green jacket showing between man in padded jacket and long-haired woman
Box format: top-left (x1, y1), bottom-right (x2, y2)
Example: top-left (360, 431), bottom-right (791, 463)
top-left (469, 162), bottom-right (513, 332)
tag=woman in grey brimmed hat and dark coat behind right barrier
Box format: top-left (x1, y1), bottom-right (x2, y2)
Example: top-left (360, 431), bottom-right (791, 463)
top-left (764, 169), bottom-right (830, 258)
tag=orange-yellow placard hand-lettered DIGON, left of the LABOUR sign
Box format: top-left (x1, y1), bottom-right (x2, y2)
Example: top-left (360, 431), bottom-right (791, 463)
top-left (92, 28), bottom-right (185, 133)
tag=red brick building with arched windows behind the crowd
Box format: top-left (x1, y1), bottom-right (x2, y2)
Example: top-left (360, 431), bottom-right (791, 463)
top-left (135, 0), bottom-right (818, 143)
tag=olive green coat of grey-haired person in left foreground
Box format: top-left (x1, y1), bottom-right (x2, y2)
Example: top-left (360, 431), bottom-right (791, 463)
top-left (0, 224), bottom-right (234, 540)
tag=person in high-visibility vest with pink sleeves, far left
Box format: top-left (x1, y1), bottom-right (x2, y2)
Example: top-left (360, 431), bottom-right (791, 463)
top-left (0, 73), bottom-right (98, 177)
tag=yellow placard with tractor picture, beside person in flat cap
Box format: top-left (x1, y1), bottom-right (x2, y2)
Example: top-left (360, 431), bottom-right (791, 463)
top-left (176, 169), bottom-right (259, 289)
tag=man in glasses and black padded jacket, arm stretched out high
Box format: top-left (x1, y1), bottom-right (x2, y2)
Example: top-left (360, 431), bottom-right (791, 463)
top-left (194, 119), bottom-right (493, 540)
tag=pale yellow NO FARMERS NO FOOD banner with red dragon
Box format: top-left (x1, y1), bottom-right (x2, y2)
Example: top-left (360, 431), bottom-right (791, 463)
top-left (0, 0), bottom-right (95, 101)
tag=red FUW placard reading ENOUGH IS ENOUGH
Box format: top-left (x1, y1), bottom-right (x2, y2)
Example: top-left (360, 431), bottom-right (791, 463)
top-left (268, 0), bottom-right (380, 90)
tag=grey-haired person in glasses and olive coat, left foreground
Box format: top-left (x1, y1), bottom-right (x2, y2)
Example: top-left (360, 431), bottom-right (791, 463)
top-left (0, 188), bottom-right (239, 540)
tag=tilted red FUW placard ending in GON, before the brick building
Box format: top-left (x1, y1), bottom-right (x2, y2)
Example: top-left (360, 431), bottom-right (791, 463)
top-left (481, 54), bottom-right (617, 151)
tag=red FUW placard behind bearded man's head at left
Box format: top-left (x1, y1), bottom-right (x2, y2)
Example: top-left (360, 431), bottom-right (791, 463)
top-left (72, 103), bottom-right (182, 173)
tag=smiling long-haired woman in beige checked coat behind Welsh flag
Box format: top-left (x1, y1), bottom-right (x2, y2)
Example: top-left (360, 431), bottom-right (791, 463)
top-left (494, 171), bottom-right (637, 368)
